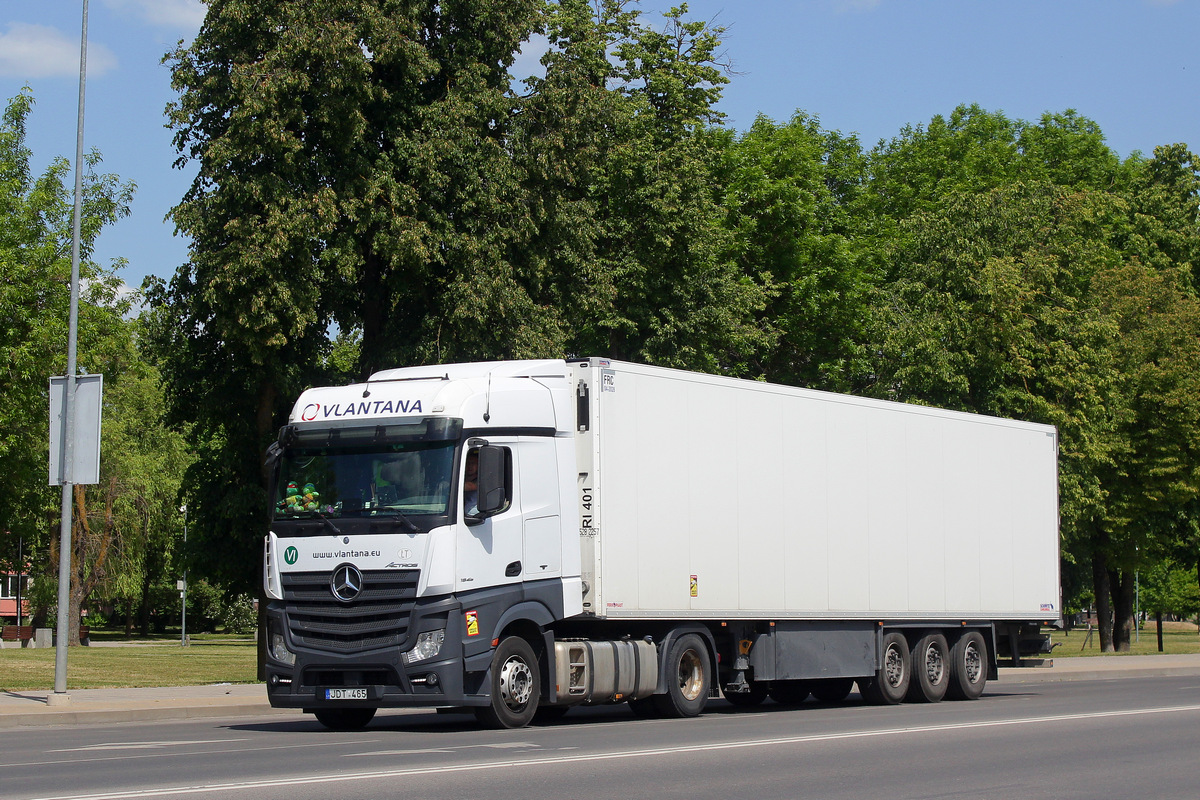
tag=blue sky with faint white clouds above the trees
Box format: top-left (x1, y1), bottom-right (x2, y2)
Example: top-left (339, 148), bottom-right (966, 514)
top-left (0, 0), bottom-right (1200, 293)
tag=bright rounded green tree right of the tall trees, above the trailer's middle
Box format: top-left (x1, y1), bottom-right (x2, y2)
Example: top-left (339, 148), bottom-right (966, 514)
top-left (721, 113), bottom-right (871, 391)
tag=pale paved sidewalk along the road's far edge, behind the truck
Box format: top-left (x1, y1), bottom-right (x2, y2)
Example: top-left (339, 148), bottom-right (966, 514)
top-left (0, 655), bottom-right (1200, 728)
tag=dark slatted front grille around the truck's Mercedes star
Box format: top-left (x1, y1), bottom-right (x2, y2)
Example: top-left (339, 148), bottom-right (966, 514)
top-left (281, 570), bottom-right (421, 654)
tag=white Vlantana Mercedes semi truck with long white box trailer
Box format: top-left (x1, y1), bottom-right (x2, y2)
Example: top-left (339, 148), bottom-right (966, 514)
top-left (264, 359), bottom-right (1061, 729)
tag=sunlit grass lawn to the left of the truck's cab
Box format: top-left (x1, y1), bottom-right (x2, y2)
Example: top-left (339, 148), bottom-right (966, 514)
top-left (0, 637), bottom-right (257, 692)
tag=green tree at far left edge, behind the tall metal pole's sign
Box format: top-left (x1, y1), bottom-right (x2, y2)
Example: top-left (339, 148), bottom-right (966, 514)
top-left (0, 90), bottom-right (133, 614)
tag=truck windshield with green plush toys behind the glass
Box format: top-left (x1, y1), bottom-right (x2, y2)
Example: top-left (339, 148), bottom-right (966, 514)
top-left (275, 441), bottom-right (455, 519)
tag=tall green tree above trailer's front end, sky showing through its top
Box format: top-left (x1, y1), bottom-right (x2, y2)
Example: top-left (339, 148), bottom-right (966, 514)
top-left (515, 0), bottom-right (766, 372)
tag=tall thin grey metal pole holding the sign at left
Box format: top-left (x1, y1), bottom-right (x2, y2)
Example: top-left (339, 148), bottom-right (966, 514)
top-left (54, 0), bottom-right (88, 703)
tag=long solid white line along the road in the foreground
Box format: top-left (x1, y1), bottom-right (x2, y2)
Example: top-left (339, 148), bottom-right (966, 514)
top-left (23, 705), bottom-right (1200, 800)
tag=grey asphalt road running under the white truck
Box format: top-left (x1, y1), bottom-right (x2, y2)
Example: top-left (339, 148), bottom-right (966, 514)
top-left (0, 676), bottom-right (1200, 800)
